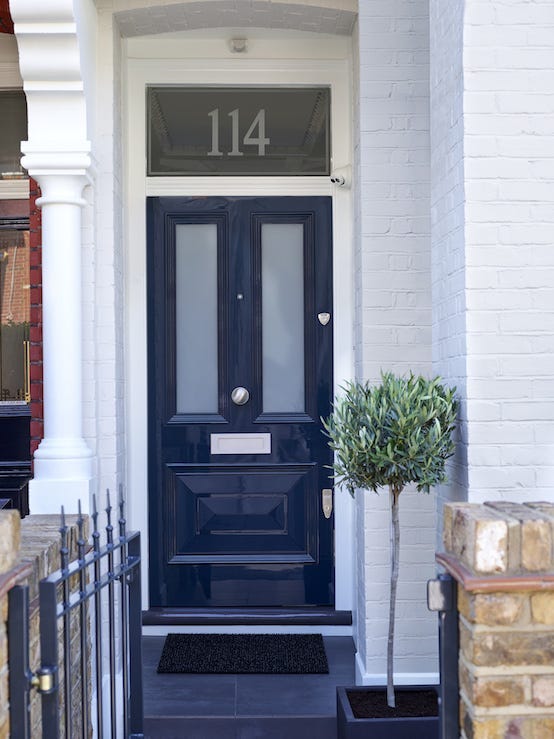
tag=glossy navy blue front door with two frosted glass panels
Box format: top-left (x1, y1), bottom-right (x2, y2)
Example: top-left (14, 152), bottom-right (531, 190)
top-left (148, 197), bottom-right (334, 609)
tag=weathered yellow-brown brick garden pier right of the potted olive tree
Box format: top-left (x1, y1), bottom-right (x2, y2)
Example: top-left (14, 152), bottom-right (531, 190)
top-left (437, 503), bottom-right (554, 739)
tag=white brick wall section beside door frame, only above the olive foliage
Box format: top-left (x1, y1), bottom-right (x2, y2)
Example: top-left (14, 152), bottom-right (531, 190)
top-left (355, 0), bottom-right (431, 379)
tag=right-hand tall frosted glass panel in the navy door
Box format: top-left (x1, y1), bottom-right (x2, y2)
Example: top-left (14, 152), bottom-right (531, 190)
top-left (262, 223), bottom-right (305, 413)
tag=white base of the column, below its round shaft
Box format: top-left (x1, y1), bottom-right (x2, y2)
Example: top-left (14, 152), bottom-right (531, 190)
top-left (29, 439), bottom-right (96, 514)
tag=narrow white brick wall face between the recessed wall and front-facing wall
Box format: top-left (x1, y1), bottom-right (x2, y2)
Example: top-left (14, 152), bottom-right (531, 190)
top-left (429, 0), bottom-right (468, 549)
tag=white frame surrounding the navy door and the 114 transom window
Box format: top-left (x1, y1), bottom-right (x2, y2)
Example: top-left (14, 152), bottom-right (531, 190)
top-left (123, 31), bottom-right (354, 620)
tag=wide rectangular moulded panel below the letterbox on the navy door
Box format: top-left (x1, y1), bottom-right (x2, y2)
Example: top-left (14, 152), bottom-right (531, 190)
top-left (167, 465), bottom-right (318, 565)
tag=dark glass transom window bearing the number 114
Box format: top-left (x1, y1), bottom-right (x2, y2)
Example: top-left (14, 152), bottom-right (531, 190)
top-left (147, 87), bottom-right (330, 176)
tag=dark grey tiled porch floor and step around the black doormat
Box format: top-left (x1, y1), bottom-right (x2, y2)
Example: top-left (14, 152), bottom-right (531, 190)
top-left (143, 637), bottom-right (354, 739)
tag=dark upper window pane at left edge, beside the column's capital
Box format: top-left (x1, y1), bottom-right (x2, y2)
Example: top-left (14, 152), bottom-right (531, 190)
top-left (0, 90), bottom-right (27, 179)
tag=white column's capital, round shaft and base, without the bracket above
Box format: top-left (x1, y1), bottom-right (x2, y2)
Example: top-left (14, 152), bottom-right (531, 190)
top-left (23, 152), bottom-right (94, 513)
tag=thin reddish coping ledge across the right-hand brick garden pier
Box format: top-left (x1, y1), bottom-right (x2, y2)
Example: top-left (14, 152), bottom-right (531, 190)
top-left (435, 552), bottom-right (554, 593)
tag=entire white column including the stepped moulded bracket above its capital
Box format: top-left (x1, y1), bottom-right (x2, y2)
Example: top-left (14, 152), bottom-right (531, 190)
top-left (10, 0), bottom-right (96, 513)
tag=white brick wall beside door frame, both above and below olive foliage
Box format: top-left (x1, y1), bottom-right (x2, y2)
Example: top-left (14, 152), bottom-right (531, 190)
top-left (354, 0), bottom-right (437, 682)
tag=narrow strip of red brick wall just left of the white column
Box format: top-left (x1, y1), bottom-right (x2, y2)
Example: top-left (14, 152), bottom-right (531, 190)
top-left (29, 179), bottom-right (44, 454)
